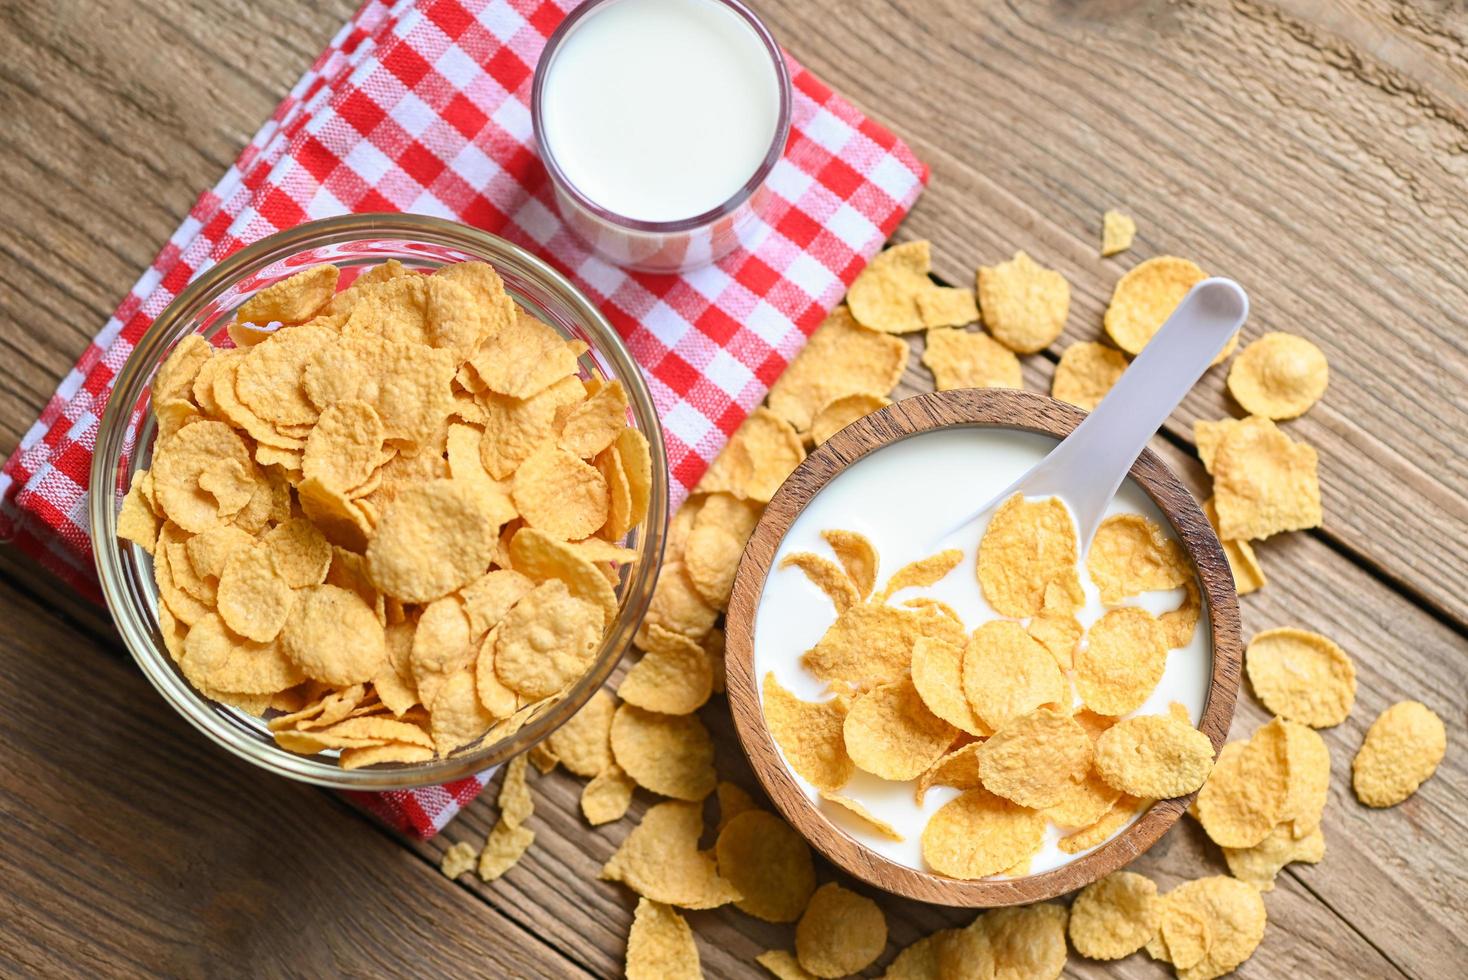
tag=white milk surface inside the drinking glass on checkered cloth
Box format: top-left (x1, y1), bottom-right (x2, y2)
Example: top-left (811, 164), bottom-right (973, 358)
top-left (542, 0), bottom-right (781, 222)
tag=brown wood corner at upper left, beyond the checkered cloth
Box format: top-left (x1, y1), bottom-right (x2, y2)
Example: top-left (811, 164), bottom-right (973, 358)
top-left (0, 0), bottom-right (357, 455)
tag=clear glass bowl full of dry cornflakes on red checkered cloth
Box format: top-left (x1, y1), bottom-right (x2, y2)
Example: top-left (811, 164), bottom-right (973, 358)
top-left (88, 214), bottom-right (668, 791)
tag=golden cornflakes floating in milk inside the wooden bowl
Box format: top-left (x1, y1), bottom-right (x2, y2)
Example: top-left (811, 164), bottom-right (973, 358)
top-left (763, 496), bottom-right (1213, 879)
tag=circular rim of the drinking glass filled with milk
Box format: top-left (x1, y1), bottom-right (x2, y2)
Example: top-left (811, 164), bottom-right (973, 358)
top-left (530, 0), bottom-right (794, 235)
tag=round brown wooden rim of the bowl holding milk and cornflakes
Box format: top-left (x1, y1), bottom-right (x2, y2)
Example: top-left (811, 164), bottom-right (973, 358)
top-left (725, 389), bottom-right (1242, 908)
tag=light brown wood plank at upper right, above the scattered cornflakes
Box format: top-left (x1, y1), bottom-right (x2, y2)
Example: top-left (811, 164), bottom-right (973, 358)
top-left (771, 0), bottom-right (1468, 624)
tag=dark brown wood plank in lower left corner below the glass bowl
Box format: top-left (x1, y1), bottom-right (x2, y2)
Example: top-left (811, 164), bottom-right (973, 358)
top-left (0, 579), bottom-right (581, 976)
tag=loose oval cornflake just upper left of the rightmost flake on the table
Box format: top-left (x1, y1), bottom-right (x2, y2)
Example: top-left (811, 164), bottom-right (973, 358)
top-left (1243, 626), bottom-right (1356, 728)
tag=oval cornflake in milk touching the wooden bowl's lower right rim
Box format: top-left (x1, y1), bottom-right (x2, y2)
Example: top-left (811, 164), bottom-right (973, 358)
top-left (1095, 714), bottom-right (1213, 800)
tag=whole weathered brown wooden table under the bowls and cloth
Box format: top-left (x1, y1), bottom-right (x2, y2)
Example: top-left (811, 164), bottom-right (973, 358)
top-left (0, 0), bottom-right (1468, 979)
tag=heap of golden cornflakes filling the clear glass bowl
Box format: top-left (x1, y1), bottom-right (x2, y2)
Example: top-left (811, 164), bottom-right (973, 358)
top-left (119, 261), bottom-right (652, 762)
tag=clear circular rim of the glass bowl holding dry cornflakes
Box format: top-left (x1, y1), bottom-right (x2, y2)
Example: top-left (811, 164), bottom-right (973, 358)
top-left (87, 213), bottom-right (668, 791)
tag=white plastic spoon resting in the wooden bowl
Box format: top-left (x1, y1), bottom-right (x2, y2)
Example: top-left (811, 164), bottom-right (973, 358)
top-left (944, 279), bottom-right (1249, 556)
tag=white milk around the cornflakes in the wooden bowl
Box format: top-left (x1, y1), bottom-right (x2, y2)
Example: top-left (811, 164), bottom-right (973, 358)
top-left (755, 425), bottom-right (1213, 877)
